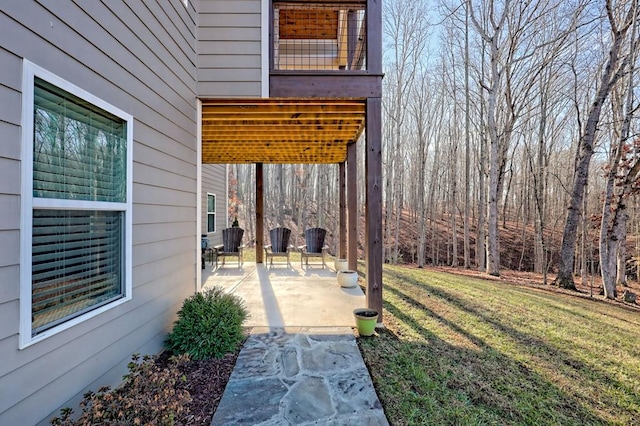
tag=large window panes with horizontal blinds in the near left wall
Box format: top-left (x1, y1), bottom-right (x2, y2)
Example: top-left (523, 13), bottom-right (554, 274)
top-left (22, 66), bottom-right (132, 337)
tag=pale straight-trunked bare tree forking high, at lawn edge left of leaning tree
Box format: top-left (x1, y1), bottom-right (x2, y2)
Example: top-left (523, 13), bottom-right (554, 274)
top-left (467, 0), bottom-right (573, 275)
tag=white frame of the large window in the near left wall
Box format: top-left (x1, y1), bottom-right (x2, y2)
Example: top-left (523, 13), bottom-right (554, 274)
top-left (19, 59), bottom-right (133, 349)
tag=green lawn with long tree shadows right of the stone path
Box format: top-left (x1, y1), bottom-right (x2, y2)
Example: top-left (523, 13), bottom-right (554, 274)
top-left (359, 266), bottom-right (640, 425)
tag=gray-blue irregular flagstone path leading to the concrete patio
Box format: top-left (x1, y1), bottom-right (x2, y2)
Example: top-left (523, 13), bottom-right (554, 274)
top-left (211, 327), bottom-right (388, 426)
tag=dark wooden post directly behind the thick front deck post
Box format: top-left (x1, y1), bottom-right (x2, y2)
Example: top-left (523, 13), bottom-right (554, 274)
top-left (347, 142), bottom-right (358, 271)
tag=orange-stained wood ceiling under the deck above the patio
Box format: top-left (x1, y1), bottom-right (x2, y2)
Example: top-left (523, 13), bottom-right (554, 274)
top-left (202, 98), bottom-right (365, 164)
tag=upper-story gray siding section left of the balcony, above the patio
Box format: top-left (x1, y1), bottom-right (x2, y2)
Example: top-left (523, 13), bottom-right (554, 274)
top-left (198, 0), bottom-right (265, 98)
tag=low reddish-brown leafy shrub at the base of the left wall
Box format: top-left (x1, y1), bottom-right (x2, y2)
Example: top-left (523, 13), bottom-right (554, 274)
top-left (51, 354), bottom-right (191, 426)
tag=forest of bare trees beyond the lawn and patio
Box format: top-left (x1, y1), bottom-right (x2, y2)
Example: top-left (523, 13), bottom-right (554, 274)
top-left (229, 0), bottom-right (640, 298)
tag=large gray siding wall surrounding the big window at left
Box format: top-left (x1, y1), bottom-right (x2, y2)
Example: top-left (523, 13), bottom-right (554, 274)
top-left (0, 1), bottom-right (200, 425)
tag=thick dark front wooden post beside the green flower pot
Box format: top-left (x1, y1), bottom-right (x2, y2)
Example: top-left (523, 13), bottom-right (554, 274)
top-left (365, 98), bottom-right (382, 323)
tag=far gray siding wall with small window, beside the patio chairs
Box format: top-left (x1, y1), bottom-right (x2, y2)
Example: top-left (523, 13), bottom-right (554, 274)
top-left (202, 164), bottom-right (230, 246)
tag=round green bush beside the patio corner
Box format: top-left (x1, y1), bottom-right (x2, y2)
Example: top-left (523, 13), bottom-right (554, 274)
top-left (166, 287), bottom-right (247, 360)
